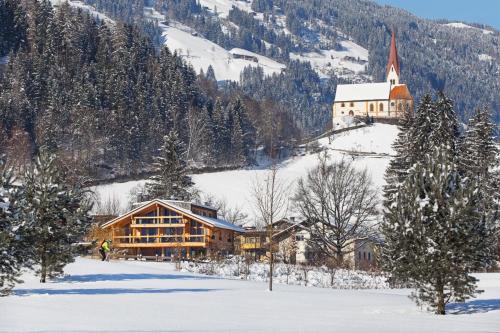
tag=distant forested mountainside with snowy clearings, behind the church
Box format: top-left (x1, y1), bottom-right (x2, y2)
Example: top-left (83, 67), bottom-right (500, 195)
top-left (76, 0), bottom-right (500, 126)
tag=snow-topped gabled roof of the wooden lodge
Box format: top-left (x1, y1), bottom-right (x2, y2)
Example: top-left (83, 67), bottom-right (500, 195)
top-left (101, 199), bottom-right (244, 232)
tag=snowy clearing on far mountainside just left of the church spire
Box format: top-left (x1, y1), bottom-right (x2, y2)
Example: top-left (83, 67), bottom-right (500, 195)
top-left (290, 40), bottom-right (368, 78)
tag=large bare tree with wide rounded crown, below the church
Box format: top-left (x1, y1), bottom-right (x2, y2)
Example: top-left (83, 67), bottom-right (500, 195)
top-left (295, 154), bottom-right (377, 266)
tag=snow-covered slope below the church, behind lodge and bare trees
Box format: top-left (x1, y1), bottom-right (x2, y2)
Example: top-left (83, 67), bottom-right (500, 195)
top-left (94, 124), bottom-right (398, 220)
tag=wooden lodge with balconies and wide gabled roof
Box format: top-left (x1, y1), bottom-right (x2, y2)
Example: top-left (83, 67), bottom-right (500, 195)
top-left (101, 199), bottom-right (244, 259)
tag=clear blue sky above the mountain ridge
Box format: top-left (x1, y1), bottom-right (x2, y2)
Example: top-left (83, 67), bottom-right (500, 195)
top-left (375, 0), bottom-right (500, 30)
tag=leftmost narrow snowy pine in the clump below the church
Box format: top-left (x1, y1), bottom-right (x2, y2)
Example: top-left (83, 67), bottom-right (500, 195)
top-left (384, 109), bottom-right (414, 206)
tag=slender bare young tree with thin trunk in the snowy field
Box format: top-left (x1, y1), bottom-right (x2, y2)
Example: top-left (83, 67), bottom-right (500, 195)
top-left (252, 163), bottom-right (289, 291)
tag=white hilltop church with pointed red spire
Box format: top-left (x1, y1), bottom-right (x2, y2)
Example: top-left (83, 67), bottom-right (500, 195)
top-left (333, 31), bottom-right (413, 119)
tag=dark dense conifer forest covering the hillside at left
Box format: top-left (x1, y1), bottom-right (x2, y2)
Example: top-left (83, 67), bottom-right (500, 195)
top-left (0, 0), bottom-right (296, 178)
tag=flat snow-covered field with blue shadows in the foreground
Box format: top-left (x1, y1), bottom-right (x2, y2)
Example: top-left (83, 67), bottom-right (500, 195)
top-left (0, 259), bottom-right (500, 333)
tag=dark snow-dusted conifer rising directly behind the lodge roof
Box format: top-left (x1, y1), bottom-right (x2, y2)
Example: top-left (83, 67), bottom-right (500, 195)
top-left (146, 131), bottom-right (193, 200)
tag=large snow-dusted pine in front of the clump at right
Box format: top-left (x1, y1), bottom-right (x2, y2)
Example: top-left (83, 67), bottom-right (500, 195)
top-left (381, 146), bottom-right (493, 314)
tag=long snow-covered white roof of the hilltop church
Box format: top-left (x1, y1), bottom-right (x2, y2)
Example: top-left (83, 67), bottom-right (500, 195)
top-left (335, 82), bottom-right (391, 102)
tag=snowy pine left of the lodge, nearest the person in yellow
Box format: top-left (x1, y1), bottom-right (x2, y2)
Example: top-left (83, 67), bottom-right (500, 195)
top-left (22, 150), bottom-right (92, 282)
